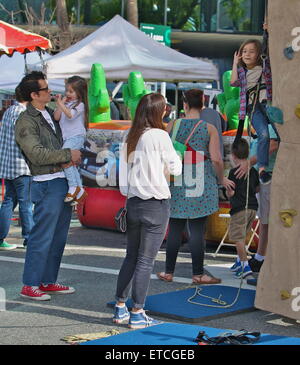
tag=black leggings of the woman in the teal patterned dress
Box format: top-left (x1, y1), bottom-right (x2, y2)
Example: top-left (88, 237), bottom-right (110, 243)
top-left (166, 217), bottom-right (207, 275)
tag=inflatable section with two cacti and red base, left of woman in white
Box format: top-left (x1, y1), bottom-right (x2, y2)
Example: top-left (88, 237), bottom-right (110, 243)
top-left (77, 64), bottom-right (142, 229)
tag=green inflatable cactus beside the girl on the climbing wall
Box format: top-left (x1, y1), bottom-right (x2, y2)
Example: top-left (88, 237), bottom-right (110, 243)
top-left (217, 70), bottom-right (240, 129)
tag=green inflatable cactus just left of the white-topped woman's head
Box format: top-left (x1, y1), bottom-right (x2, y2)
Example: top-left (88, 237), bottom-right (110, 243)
top-left (122, 71), bottom-right (150, 120)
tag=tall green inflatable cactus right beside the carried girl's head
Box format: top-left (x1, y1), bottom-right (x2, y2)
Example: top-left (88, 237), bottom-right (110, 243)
top-left (88, 63), bottom-right (111, 123)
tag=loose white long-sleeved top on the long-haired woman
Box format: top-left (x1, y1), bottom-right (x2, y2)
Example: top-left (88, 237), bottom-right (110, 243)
top-left (119, 128), bottom-right (182, 200)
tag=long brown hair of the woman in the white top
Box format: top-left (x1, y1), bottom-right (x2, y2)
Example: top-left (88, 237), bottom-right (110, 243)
top-left (126, 93), bottom-right (166, 160)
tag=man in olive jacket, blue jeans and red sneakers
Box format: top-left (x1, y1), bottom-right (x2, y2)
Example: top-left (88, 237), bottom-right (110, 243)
top-left (15, 72), bottom-right (81, 300)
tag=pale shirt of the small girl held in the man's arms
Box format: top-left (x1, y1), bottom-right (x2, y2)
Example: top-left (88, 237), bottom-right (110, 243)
top-left (59, 101), bottom-right (86, 141)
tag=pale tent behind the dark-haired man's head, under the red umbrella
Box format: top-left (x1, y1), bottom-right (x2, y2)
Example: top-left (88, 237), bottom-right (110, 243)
top-left (0, 52), bottom-right (64, 94)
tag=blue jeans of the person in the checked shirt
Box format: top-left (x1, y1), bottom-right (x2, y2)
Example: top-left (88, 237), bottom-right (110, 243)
top-left (0, 175), bottom-right (33, 243)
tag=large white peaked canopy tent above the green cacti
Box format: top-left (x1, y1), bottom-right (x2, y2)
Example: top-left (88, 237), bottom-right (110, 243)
top-left (45, 15), bottom-right (219, 82)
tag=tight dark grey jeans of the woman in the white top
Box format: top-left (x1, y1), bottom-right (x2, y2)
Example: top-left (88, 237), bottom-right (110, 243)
top-left (116, 197), bottom-right (170, 308)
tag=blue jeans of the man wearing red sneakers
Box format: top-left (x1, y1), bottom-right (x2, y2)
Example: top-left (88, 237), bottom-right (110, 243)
top-left (23, 179), bottom-right (72, 286)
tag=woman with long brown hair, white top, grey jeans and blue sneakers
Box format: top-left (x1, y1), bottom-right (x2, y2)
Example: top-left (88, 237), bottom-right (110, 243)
top-left (113, 93), bottom-right (182, 328)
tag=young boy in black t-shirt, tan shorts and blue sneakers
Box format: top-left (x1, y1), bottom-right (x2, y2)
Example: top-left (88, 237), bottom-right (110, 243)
top-left (226, 138), bottom-right (259, 278)
